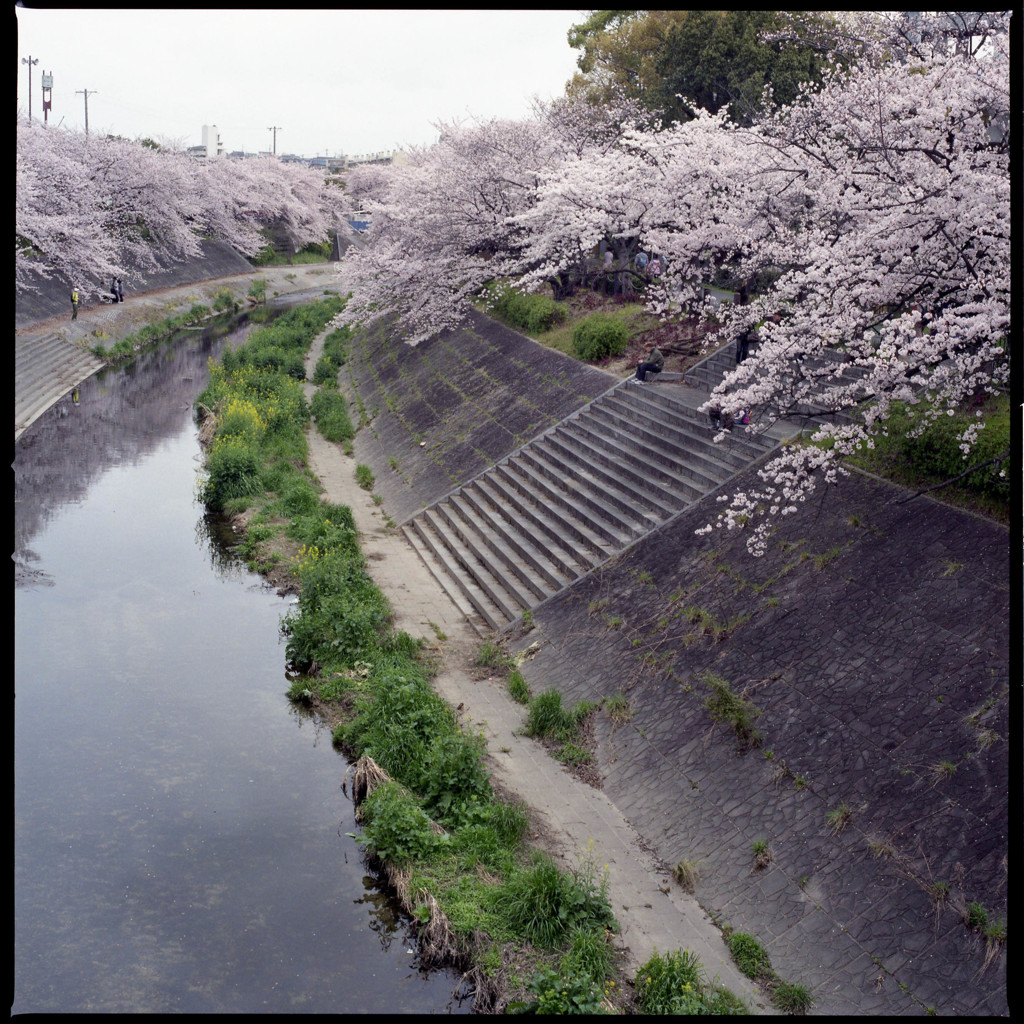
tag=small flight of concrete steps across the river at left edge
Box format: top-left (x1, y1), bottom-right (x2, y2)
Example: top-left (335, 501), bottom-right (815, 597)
top-left (14, 332), bottom-right (103, 441)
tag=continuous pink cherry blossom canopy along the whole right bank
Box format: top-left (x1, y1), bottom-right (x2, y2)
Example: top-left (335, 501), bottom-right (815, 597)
top-left (329, 13), bottom-right (1010, 553)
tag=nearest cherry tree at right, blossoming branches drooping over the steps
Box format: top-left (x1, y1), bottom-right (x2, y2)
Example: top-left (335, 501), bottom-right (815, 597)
top-left (679, 12), bottom-right (1010, 553)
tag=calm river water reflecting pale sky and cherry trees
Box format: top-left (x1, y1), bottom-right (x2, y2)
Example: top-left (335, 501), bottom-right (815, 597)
top-left (12, 321), bottom-right (469, 1013)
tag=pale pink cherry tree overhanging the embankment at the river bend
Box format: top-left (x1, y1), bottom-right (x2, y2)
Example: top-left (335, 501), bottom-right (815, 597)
top-left (341, 99), bottom-right (655, 344)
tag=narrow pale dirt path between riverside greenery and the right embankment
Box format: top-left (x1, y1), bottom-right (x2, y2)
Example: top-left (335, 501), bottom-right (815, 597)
top-left (306, 332), bottom-right (771, 1013)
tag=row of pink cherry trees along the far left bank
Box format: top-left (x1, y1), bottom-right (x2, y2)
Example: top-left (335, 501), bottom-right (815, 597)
top-left (14, 120), bottom-right (342, 290)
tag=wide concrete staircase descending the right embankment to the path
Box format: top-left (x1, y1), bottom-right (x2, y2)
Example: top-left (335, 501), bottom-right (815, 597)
top-left (401, 374), bottom-right (778, 629)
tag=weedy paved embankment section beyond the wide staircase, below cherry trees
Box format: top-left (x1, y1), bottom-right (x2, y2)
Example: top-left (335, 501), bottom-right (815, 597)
top-left (339, 312), bottom-right (616, 523)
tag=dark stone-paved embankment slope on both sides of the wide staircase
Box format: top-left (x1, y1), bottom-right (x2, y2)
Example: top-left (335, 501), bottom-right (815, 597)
top-left (341, 317), bottom-right (1009, 1014)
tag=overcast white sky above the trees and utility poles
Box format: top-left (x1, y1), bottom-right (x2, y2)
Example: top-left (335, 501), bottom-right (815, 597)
top-left (16, 4), bottom-right (583, 157)
